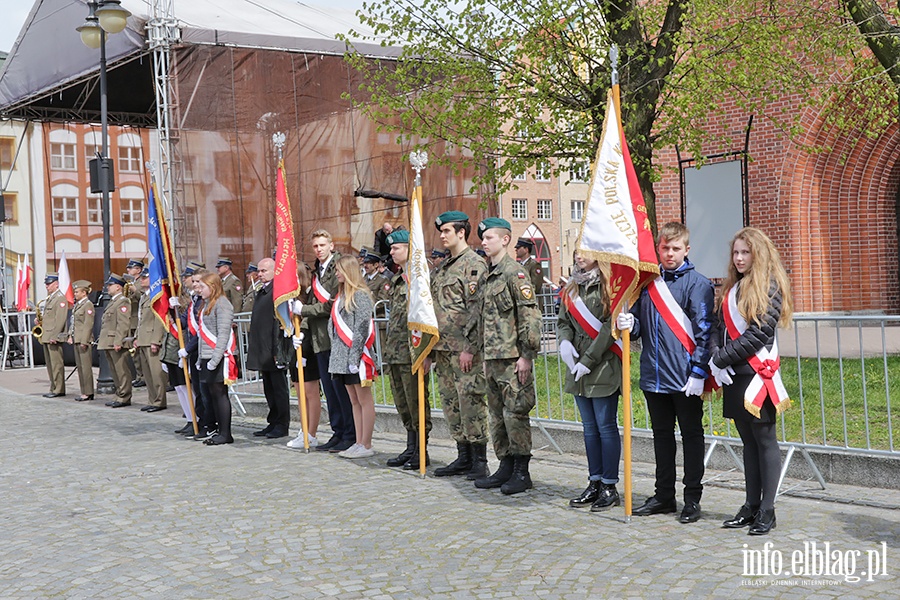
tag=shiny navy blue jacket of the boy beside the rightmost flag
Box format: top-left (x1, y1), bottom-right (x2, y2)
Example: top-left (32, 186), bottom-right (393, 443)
top-left (631, 259), bottom-right (715, 394)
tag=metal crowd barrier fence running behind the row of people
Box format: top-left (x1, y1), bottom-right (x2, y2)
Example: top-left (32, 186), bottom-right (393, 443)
top-left (227, 294), bottom-right (900, 487)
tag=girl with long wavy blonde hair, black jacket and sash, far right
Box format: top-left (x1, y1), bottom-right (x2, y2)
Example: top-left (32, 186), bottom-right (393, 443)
top-left (709, 227), bottom-right (793, 535)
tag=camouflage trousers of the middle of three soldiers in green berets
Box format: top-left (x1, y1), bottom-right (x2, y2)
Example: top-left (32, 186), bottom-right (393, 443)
top-left (431, 352), bottom-right (488, 444)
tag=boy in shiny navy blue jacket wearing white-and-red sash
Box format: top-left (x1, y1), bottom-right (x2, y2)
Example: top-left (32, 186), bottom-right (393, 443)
top-left (616, 222), bottom-right (715, 523)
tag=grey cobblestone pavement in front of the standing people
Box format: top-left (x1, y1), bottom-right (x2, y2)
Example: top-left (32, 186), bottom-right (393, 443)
top-left (0, 370), bottom-right (900, 600)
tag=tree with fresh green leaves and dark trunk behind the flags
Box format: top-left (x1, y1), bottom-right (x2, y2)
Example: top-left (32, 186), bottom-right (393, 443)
top-left (350, 0), bottom-right (892, 223)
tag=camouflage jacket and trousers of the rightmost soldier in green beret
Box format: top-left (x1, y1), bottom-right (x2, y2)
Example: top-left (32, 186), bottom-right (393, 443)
top-left (480, 255), bottom-right (541, 459)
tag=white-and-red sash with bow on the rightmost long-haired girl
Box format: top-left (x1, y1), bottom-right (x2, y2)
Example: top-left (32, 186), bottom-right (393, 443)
top-left (722, 286), bottom-right (791, 418)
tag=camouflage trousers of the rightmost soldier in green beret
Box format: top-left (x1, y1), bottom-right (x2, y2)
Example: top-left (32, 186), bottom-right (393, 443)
top-left (484, 358), bottom-right (537, 458)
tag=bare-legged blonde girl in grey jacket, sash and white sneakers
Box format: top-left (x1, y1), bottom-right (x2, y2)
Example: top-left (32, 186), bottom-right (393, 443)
top-left (328, 256), bottom-right (376, 458)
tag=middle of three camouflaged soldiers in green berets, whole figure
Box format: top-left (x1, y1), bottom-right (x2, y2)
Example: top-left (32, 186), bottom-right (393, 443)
top-left (431, 210), bottom-right (488, 480)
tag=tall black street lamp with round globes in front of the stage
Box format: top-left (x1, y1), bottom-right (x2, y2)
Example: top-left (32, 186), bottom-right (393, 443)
top-left (75, 0), bottom-right (131, 393)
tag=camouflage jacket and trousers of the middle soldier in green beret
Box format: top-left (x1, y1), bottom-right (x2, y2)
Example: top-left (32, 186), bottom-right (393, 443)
top-left (431, 248), bottom-right (488, 445)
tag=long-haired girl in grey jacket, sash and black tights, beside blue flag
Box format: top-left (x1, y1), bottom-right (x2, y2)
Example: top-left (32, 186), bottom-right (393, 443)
top-left (198, 273), bottom-right (237, 446)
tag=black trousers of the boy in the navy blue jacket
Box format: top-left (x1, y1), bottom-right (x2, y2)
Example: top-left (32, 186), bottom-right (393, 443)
top-left (644, 391), bottom-right (706, 503)
